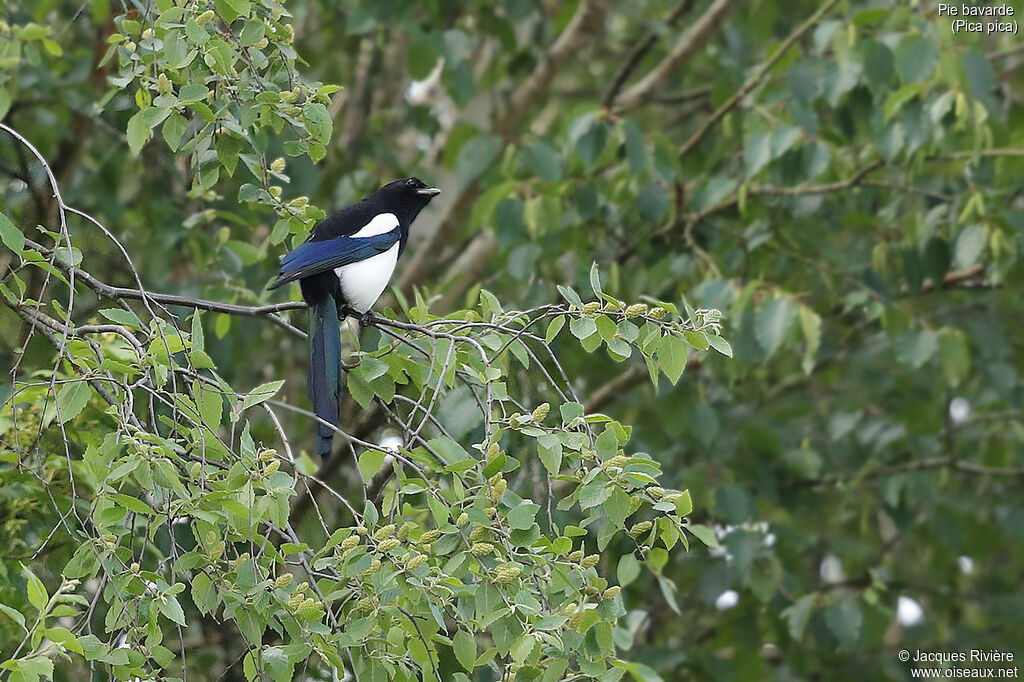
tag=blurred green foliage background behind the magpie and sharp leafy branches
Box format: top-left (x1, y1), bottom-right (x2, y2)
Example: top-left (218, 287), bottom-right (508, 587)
top-left (0, 0), bottom-right (1024, 680)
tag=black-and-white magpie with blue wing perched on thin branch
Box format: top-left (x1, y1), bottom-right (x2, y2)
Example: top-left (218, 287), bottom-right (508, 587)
top-left (267, 177), bottom-right (441, 457)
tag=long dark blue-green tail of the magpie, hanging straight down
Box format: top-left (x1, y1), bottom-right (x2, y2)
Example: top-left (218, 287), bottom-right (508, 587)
top-left (306, 296), bottom-right (344, 457)
